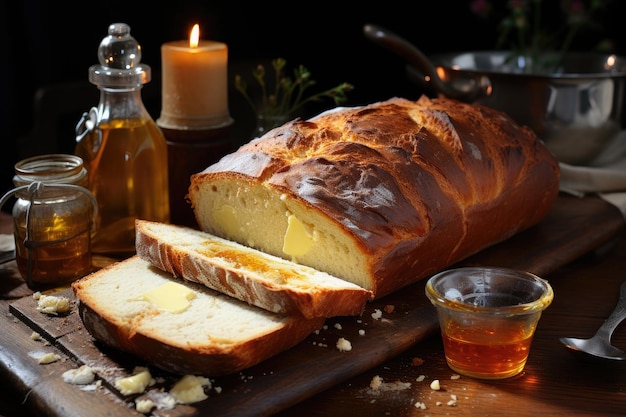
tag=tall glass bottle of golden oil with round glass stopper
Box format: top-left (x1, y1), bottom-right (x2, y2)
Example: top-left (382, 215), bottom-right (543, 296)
top-left (75, 23), bottom-right (170, 258)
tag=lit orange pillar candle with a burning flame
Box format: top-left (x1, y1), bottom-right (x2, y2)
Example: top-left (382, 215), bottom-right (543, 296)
top-left (157, 25), bottom-right (232, 130)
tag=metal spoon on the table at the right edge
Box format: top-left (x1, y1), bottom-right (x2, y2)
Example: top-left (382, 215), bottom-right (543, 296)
top-left (560, 282), bottom-right (626, 361)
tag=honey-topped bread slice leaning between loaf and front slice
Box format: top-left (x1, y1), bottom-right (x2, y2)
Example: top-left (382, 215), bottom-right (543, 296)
top-left (135, 219), bottom-right (372, 318)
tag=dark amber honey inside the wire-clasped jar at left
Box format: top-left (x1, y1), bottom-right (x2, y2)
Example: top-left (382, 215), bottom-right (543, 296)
top-left (15, 203), bottom-right (92, 290)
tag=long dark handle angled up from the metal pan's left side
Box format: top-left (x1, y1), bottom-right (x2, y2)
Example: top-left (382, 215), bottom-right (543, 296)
top-left (363, 24), bottom-right (491, 103)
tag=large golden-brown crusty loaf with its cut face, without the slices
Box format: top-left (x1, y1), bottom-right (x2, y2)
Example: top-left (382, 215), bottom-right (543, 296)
top-left (188, 97), bottom-right (559, 298)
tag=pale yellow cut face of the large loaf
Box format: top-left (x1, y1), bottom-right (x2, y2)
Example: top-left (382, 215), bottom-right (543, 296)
top-left (193, 178), bottom-right (372, 290)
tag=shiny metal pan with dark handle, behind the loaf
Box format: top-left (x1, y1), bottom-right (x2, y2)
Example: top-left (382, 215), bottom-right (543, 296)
top-left (364, 25), bottom-right (626, 166)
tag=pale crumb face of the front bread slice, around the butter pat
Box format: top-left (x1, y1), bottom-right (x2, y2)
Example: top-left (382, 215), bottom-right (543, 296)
top-left (75, 258), bottom-right (308, 351)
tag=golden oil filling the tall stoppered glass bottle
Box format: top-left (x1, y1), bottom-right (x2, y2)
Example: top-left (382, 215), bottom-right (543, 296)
top-left (76, 119), bottom-right (170, 256)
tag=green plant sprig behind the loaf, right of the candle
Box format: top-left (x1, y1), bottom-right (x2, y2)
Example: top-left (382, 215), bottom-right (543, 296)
top-left (235, 58), bottom-right (354, 118)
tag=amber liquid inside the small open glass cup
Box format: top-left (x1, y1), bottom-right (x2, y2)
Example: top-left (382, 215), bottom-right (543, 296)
top-left (442, 321), bottom-right (533, 379)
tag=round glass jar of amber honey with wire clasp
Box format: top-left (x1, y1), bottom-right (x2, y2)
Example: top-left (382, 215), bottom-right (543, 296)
top-left (0, 154), bottom-right (98, 290)
